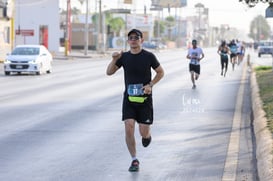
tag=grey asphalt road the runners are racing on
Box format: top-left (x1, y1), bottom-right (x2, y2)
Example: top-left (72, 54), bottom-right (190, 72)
top-left (0, 48), bottom-right (257, 181)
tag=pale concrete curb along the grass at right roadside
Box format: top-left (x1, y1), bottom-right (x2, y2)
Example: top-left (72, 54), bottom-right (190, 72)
top-left (250, 64), bottom-right (273, 181)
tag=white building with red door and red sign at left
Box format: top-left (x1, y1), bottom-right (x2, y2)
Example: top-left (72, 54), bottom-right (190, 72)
top-left (14, 0), bottom-right (60, 52)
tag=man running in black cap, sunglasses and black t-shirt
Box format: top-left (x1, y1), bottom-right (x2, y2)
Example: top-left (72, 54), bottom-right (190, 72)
top-left (106, 29), bottom-right (164, 172)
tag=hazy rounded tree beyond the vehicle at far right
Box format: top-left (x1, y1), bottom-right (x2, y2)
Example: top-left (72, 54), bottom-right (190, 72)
top-left (249, 15), bottom-right (270, 41)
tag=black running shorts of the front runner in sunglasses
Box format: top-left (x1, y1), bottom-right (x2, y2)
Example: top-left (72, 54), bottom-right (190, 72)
top-left (122, 95), bottom-right (153, 124)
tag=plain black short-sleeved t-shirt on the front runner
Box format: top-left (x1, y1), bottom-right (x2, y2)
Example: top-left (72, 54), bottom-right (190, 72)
top-left (116, 49), bottom-right (160, 95)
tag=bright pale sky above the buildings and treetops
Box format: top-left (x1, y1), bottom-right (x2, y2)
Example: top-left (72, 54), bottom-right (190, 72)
top-left (60, 0), bottom-right (273, 33)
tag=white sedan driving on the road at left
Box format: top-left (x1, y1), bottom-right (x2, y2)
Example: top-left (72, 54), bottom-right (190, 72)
top-left (4, 45), bottom-right (53, 75)
